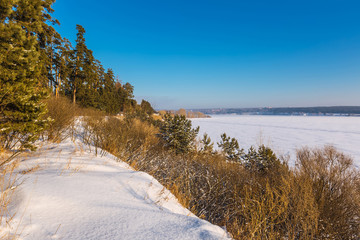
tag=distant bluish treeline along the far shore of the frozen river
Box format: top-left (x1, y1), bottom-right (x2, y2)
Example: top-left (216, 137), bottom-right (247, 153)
top-left (194, 106), bottom-right (360, 116)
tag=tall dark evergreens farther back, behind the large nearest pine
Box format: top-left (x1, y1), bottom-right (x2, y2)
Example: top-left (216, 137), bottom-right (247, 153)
top-left (53, 25), bottom-right (136, 114)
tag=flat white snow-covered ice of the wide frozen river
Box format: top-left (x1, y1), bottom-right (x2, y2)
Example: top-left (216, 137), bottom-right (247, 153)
top-left (192, 115), bottom-right (360, 167)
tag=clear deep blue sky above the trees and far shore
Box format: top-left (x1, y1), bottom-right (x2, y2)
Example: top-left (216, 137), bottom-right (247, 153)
top-left (53, 0), bottom-right (360, 109)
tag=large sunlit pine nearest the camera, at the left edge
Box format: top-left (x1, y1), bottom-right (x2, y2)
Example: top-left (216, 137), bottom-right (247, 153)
top-left (0, 1), bottom-right (48, 150)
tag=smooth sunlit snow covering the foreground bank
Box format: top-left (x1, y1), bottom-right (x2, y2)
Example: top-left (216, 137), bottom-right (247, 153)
top-left (10, 140), bottom-right (228, 240)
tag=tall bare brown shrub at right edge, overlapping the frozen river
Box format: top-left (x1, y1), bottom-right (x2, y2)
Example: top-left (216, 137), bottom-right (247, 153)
top-left (297, 146), bottom-right (360, 239)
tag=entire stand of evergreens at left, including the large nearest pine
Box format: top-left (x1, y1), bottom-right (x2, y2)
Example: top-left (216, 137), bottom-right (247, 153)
top-left (0, 0), bottom-right (154, 152)
